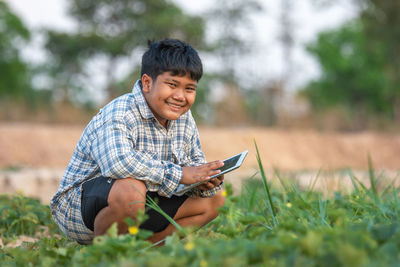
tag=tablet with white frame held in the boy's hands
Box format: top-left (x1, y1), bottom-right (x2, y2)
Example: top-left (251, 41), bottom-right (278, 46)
top-left (175, 150), bottom-right (248, 196)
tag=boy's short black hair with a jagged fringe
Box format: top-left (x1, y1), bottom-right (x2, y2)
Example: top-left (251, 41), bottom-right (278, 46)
top-left (141, 39), bottom-right (203, 81)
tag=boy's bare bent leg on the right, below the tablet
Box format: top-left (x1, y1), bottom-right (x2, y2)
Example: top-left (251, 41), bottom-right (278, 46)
top-left (149, 192), bottom-right (225, 243)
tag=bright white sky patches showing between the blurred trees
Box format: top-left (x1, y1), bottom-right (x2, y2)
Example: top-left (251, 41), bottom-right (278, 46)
top-left (5, 0), bottom-right (356, 98)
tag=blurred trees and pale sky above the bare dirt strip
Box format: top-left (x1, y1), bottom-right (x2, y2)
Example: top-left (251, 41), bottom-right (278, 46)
top-left (0, 0), bottom-right (400, 130)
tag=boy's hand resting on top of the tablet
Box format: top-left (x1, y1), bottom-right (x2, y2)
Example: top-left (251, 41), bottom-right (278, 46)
top-left (181, 160), bottom-right (224, 184)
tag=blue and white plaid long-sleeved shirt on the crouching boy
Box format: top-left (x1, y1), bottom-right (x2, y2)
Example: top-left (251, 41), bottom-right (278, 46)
top-left (50, 81), bottom-right (221, 243)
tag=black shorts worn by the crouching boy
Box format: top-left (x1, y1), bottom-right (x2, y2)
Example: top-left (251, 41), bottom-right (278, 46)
top-left (81, 176), bottom-right (188, 233)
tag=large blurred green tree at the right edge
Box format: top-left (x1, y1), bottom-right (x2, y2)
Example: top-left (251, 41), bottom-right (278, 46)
top-left (302, 0), bottom-right (400, 126)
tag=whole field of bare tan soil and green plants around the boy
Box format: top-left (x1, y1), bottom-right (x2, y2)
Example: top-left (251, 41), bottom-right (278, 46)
top-left (0, 125), bottom-right (400, 267)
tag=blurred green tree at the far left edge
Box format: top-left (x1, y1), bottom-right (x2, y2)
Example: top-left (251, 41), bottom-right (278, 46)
top-left (0, 1), bottom-right (32, 102)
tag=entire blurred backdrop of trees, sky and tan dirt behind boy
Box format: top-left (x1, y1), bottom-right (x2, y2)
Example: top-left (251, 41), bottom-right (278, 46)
top-left (0, 0), bottom-right (400, 202)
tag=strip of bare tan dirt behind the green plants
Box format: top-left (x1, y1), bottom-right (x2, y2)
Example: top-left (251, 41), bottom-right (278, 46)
top-left (0, 123), bottom-right (400, 201)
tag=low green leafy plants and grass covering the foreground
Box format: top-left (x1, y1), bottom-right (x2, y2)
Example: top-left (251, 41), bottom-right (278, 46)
top-left (0, 154), bottom-right (400, 267)
